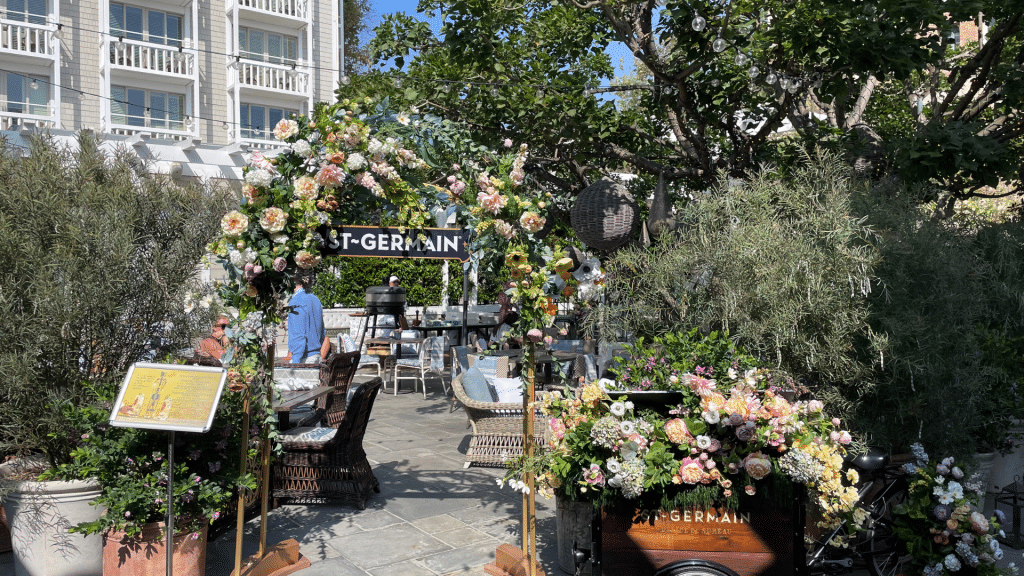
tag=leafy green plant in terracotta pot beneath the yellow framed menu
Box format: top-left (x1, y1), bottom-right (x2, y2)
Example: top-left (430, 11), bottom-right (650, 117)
top-left (44, 377), bottom-right (256, 574)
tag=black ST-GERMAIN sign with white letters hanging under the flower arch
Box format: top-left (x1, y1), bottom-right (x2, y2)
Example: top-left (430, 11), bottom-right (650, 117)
top-left (319, 225), bottom-right (469, 262)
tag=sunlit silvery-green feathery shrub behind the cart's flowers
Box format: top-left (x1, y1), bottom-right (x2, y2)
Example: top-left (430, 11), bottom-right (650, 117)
top-left (587, 152), bottom-right (885, 412)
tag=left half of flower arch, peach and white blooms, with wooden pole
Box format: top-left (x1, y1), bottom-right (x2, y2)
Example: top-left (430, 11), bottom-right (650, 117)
top-left (208, 99), bottom-right (444, 572)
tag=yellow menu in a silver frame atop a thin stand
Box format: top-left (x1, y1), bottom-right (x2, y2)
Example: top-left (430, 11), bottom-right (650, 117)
top-left (111, 362), bottom-right (227, 433)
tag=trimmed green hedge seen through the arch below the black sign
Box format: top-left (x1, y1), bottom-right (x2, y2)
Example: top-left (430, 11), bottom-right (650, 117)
top-left (312, 256), bottom-right (462, 307)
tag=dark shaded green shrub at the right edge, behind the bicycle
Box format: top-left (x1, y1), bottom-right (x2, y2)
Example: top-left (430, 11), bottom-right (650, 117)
top-left (857, 181), bottom-right (1024, 457)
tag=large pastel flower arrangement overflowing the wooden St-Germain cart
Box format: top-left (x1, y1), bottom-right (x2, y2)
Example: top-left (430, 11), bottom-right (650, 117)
top-left (506, 332), bottom-right (863, 526)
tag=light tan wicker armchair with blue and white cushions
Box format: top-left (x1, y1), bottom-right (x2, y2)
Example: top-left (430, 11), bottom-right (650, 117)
top-left (452, 372), bottom-right (548, 468)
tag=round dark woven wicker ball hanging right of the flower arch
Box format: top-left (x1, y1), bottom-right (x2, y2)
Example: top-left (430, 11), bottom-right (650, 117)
top-left (569, 178), bottom-right (640, 252)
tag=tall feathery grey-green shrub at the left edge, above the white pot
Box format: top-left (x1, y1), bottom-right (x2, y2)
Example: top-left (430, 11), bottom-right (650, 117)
top-left (0, 134), bottom-right (229, 462)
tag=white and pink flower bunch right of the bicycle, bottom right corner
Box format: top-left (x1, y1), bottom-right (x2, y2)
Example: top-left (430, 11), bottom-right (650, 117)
top-left (893, 444), bottom-right (1016, 576)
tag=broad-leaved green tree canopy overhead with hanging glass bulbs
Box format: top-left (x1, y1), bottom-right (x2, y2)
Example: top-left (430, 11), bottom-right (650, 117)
top-left (350, 0), bottom-right (1024, 211)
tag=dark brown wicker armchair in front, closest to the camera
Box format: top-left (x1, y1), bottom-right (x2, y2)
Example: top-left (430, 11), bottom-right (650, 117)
top-left (273, 378), bottom-right (383, 510)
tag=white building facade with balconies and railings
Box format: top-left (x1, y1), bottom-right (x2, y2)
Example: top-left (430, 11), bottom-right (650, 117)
top-left (0, 0), bottom-right (340, 166)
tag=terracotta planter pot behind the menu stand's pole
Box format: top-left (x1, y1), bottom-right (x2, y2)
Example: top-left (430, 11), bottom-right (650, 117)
top-left (103, 523), bottom-right (209, 576)
